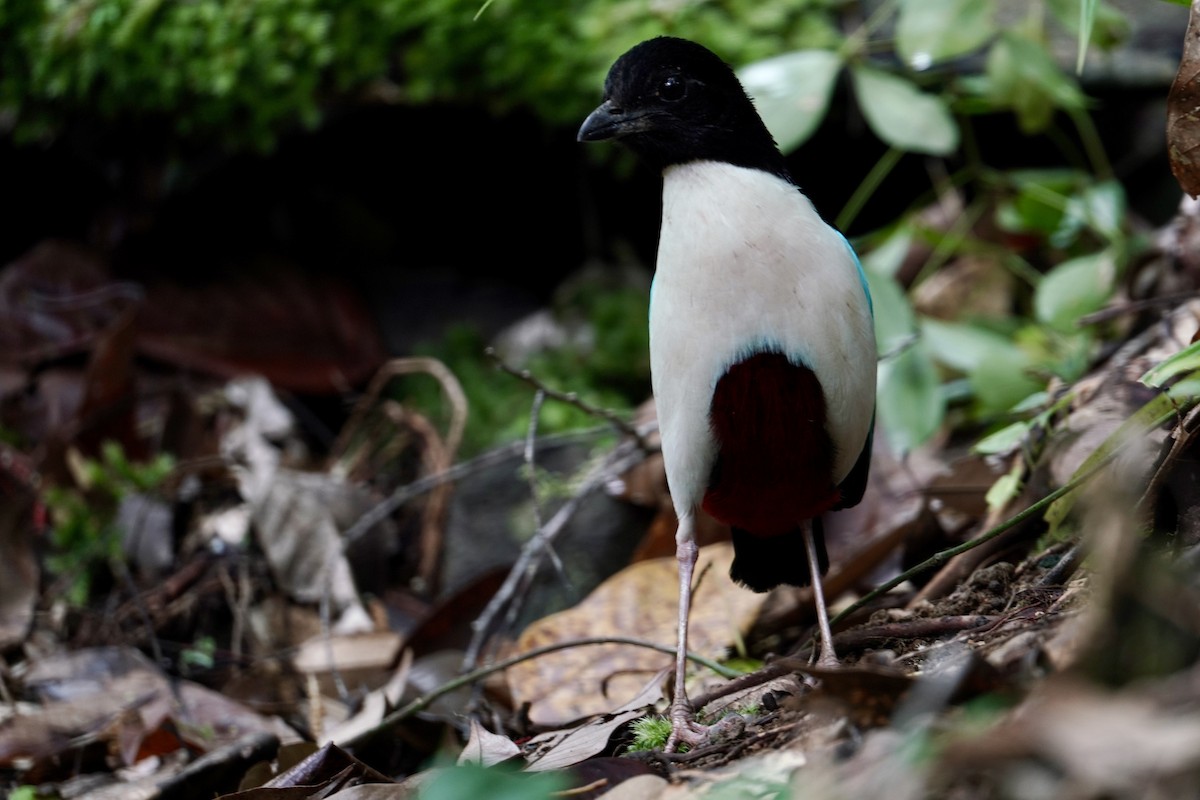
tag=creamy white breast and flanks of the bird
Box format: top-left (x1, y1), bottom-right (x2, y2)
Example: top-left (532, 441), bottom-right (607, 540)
top-left (650, 162), bottom-right (876, 515)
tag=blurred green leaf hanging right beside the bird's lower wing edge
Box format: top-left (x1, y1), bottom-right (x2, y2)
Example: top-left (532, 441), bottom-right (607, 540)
top-left (878, 342), bottom-right (946, 456)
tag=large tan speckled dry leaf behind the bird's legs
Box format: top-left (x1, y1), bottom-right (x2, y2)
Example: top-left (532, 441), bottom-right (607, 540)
top-left (508, 542), bottom-right (766, 724)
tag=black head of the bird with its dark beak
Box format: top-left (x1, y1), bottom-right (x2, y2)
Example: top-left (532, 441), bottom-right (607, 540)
top-left (578, 36), bottom-right (790, 180)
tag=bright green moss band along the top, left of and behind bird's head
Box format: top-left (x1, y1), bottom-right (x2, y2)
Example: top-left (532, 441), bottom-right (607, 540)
top-left (0, 0), bottom-right (840, 149)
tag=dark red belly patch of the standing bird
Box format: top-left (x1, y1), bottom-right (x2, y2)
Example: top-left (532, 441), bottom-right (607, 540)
top-left (701, 353), bottom-right (839, 536)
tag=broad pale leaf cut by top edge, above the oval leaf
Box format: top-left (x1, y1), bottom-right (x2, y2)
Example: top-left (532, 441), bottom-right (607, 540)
top-left (896, 0), bottom-right (996, 70)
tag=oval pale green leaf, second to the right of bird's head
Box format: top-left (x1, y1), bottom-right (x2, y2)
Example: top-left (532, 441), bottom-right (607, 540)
top-left (851, 65), bottom-right (959, 156)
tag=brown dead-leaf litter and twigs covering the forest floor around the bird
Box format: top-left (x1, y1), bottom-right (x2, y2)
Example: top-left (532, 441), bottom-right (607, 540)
top-left (7, 45), bottom-right (1200, 800)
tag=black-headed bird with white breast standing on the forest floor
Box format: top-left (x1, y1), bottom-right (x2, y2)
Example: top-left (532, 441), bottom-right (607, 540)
top-left (577, 36), bottom-right (877, 752)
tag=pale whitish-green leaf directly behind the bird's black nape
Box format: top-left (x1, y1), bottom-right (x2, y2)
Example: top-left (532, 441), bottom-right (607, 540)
top-left (738, 50), bottom-right (841, 152)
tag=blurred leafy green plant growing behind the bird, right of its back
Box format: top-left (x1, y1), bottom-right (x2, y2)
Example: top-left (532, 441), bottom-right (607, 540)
top-left (739, 0), bottom-right (1139, 453)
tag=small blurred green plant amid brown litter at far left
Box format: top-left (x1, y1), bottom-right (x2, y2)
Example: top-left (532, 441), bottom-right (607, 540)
top-left (46, 441), bottom-right (175, 606)
